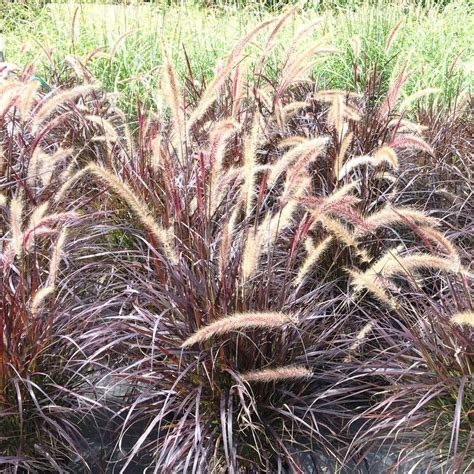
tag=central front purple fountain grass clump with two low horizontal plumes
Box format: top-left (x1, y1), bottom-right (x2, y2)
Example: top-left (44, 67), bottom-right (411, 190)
top-left (54, 14), bottom-right (378, 471)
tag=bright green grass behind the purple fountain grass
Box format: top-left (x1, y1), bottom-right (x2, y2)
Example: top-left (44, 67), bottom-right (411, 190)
top-left (3, 0), bottom-right (474, 111)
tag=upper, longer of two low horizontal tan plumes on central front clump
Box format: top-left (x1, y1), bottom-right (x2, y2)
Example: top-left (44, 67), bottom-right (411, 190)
top-left (181, 312), bottom-right (297, 347)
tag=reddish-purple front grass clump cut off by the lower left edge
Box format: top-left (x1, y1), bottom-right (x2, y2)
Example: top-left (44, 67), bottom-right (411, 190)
top-left (0, 198), bottom-right (86, 472)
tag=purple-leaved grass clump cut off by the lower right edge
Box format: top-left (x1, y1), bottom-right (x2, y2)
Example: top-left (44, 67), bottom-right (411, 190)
top-left (351, 278), bottom-right (474, 471)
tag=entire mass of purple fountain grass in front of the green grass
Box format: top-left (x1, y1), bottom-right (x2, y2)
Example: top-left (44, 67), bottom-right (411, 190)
top-left (0, 3), bottom-right (474, 472)
